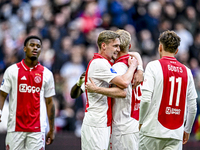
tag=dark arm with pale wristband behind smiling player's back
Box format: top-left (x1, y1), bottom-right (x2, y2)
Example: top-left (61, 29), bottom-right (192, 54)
top-left (70, 72), bottom-right (85, 98)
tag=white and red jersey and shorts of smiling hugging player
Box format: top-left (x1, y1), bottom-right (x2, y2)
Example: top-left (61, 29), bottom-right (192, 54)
top-left (81, 53), bottom-right (117, 150)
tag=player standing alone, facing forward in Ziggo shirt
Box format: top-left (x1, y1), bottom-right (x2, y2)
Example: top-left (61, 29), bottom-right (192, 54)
top-left (0, 36), bottom-right (55, 150)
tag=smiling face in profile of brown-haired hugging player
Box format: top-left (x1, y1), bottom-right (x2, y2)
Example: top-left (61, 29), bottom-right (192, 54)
top-left (105, 38), bottom-right (120, 60)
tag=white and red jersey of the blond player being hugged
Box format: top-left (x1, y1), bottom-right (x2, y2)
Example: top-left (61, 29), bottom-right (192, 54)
top-left (112, 54), bottom-right (141, 135)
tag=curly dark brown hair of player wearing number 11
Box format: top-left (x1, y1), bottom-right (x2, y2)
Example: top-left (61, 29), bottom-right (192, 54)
top-left (158, 30), bottom-right (181, 53)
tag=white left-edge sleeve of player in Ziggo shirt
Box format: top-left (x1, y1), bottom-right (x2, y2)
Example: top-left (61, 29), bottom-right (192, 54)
top-left (0, 67), bottom-right (12, 93)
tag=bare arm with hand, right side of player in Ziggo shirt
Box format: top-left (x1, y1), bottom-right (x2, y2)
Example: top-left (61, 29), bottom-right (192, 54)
top-left (45, 97), bottom-right (55, 145)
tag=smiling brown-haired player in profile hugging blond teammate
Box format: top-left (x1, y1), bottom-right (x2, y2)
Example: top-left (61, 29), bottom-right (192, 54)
top-left (81, 30), bottom-right (137, 150)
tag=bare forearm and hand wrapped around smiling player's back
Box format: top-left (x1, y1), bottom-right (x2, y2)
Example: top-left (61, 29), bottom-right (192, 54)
top-left (85, 77), bottom-right (126, 98)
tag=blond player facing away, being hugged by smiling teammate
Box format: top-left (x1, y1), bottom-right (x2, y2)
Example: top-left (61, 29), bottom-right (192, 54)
top-left (86, 30), bottom-right (143, 150)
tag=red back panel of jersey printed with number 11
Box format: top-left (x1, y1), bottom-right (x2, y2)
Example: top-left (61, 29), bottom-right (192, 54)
top-left (158, 57), bottom-right (188, 129)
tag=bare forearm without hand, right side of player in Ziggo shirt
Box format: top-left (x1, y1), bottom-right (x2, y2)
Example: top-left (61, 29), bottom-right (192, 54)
top-left (46, 98), bottom-right (55, 131)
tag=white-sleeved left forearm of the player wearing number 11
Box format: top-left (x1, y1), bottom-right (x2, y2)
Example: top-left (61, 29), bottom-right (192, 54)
top-left (139, 90), bottom-right (152, 124)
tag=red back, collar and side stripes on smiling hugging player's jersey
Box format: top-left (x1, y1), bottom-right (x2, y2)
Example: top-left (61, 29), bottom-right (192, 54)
top-left (85, 53), bottom-right (113, 126)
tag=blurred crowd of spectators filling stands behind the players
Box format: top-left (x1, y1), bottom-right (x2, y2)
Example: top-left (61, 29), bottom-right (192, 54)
top-left (0, 0), bottom-right (200, 140)
